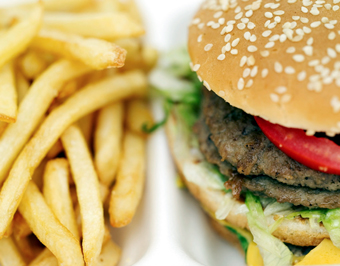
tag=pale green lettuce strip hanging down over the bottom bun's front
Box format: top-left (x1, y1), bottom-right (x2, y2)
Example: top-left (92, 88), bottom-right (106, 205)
top-left (246, 192), bottom-right (293, 266)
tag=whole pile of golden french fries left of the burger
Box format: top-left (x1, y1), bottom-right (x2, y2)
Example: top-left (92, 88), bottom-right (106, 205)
top-left (0, 0), bottom-right (157, 266)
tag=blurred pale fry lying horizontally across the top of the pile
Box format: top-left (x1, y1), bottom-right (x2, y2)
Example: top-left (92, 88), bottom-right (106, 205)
top-left (43, 12), bottom-right (145, 40)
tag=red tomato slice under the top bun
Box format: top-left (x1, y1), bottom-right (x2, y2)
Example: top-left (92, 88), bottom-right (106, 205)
top-left (255, 117), bottom-right (340, 175)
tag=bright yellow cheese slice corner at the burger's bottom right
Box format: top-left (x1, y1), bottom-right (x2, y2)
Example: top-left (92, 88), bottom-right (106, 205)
top-left (296, 239), bottom-right (340, 265)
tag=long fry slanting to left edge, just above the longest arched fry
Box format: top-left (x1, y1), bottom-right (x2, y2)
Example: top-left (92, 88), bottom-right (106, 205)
top-left (0, 60), bottom-right (90, 185)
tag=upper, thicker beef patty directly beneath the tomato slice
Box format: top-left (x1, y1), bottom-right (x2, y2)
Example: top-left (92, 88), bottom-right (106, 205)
top-left (202, 90), bottom-right (340, 191)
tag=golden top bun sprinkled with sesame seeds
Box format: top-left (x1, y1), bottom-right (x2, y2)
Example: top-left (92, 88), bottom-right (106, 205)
top-left (189, 0), bottom-right (340, 135)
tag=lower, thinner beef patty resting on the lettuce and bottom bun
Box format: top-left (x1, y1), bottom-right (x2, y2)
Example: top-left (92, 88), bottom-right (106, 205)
top-left (194, 116), bottom-right (340, 209)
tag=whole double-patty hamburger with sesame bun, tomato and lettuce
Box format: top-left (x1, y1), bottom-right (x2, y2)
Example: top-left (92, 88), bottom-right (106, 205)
top-left (161, 0), bottom-right (340, 266)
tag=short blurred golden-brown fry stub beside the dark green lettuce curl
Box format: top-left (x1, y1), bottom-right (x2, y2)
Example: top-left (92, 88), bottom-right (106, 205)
top-left (126, 99), bottom-right (154, 136)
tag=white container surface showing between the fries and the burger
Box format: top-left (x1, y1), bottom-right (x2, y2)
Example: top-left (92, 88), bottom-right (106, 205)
top-left (113, 0), bottom-right (245, 266)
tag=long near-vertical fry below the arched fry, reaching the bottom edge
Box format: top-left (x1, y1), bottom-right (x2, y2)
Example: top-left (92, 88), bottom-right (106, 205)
top-left (61, 125), bottom-right (104, 265)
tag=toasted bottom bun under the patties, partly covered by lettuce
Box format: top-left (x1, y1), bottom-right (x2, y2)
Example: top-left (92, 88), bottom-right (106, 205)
top-left (166, 111), bottom-right (329, 246)
